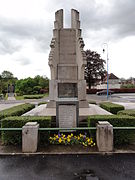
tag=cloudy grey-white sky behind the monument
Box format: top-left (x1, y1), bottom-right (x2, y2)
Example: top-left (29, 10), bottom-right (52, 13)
top-left (0, 0), bottom-right (135, 79)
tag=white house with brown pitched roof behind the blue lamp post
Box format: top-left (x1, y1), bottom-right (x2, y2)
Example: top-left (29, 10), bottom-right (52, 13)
top-left (97, 73), bottom-right (121, 89)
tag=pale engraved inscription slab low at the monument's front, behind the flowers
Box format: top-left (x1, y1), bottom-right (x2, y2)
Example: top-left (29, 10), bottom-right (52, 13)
top-left (58, 105), bottom-right (76, 128)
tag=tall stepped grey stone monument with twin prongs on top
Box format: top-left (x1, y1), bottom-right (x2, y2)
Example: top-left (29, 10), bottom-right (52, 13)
top-left (47, 9), bottom-right (88, 127)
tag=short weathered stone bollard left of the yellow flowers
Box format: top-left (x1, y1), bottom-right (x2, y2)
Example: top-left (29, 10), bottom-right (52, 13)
top-left (22, 122), bottom-right (39, 153)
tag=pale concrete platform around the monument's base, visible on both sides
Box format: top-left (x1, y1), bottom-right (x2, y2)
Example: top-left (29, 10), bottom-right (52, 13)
top-left (23, 104), bottom-right (111, 116)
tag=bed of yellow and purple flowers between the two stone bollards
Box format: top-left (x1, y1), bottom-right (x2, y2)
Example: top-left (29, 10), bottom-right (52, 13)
top-left (49, 133), bottom-right (96, 147)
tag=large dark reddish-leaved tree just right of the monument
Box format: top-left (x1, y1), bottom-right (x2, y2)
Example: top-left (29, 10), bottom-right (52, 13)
top-left (85, 50), bottom-right (106, 89)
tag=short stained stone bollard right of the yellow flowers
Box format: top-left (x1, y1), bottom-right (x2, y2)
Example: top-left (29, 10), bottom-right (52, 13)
top-left (96, 121), bottom-right (113, 152)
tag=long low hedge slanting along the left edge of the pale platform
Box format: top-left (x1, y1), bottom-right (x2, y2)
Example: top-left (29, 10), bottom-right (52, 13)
top-left (0, 103), bottom-right (35, 119)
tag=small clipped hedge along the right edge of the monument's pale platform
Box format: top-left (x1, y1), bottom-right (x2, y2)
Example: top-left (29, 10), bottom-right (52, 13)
top-left (99, 102), bottom-right (124, 114)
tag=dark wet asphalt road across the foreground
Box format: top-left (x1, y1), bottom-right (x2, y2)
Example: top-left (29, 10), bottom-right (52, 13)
top-left (0, 154), bottom-right (135, 180)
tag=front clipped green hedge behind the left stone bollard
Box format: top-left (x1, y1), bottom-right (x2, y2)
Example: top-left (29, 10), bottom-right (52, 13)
top-left (1, 116), bottom-right (51, 145)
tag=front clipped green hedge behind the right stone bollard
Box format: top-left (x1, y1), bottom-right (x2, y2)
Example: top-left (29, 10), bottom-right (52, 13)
top-left (88, 115), bottom-right (135, 145)
